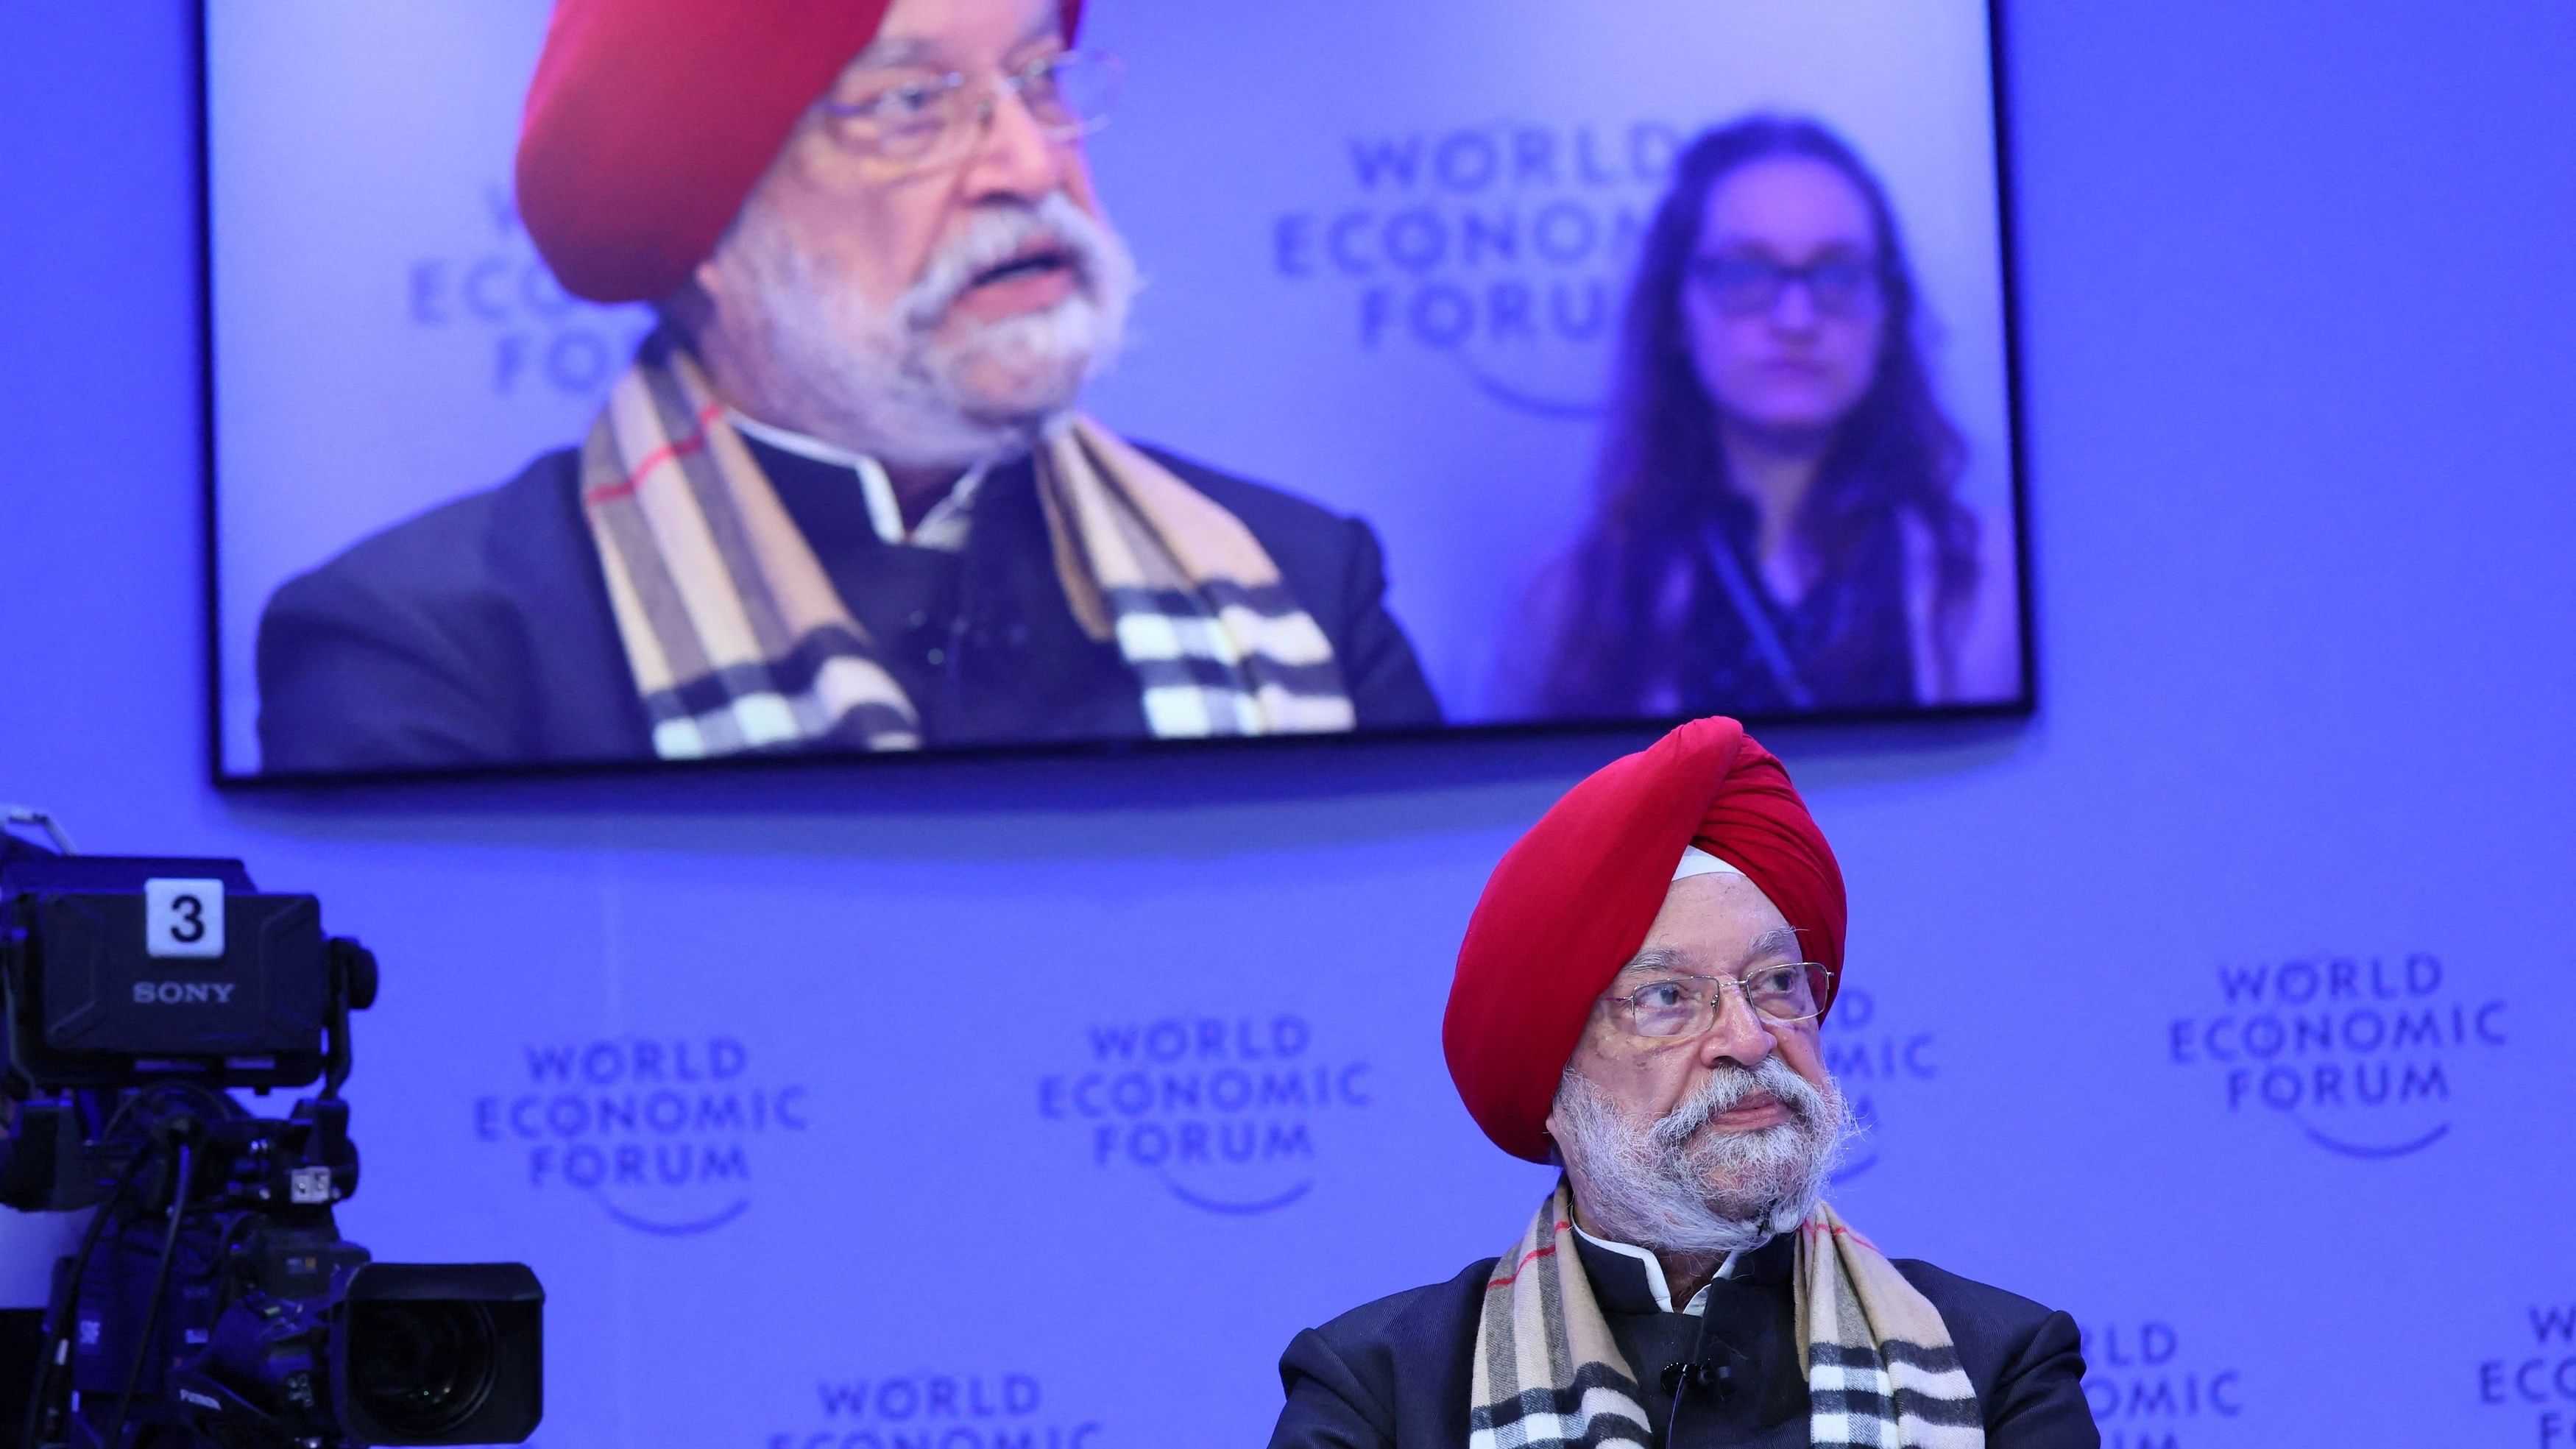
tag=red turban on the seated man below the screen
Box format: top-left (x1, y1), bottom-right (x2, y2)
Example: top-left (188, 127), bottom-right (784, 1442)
top-left (1440, 718), bottom-right (1844, 1161)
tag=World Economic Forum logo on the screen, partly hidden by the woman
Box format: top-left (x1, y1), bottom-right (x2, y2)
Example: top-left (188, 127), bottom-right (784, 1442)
top-left (1267, 118), bottom-right (1688, 417)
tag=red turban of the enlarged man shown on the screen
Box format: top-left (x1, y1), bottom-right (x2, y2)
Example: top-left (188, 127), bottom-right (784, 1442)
top-left (518, 0), bottom-right (1082, 301)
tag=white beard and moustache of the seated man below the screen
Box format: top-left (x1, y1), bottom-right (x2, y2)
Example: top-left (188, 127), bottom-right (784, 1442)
top-left (1554, 1055), bottom-right (1858, 1253)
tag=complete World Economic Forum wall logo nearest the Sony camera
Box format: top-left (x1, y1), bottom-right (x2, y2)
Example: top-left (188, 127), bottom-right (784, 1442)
top-left (472, 1035), bottom-right (814, 1238)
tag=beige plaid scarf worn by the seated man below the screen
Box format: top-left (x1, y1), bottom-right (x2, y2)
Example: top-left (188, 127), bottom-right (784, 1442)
top-left (1468, 1184), bottom-right (1986, 1449)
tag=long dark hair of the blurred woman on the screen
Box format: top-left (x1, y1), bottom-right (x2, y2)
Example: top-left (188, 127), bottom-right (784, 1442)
top-left (1538, 116), bottom-right (1976, 715)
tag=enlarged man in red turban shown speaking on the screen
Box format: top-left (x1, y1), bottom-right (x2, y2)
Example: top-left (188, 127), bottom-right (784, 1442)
top-left (261, 0), bottom-right (1437, 772)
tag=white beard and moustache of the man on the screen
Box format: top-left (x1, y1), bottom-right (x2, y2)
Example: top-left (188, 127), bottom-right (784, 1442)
top-left (724, 191), bottom-right (1136, 469)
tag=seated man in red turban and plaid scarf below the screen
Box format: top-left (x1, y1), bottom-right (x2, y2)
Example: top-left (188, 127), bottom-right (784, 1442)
top-left (1270, 718), bottom-right (2100, 1449)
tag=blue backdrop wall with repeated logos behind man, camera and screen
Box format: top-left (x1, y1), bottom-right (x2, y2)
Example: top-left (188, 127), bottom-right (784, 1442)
top-left (0, 0), bottom-right (2576, 1449)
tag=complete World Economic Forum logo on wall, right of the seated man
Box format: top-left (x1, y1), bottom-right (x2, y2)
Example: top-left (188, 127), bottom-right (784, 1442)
top-left (2164, 952), bottom-right (2507, 1158)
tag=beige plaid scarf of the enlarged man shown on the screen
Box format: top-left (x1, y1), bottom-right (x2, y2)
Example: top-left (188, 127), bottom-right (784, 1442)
top-left (582, 335), bottom-right (1353, 759)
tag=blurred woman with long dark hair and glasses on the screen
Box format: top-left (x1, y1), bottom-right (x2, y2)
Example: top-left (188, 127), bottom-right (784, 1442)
top-left (1523, 116), bottom-right (2017, 715)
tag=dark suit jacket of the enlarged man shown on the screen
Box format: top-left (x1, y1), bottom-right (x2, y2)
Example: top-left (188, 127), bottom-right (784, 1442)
top-left (258, 440), bottom-right (1440, 772)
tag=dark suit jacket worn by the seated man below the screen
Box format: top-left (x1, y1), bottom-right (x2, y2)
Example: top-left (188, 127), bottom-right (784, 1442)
top-left (1270, 1236), bottom-right (2102, 1449)
